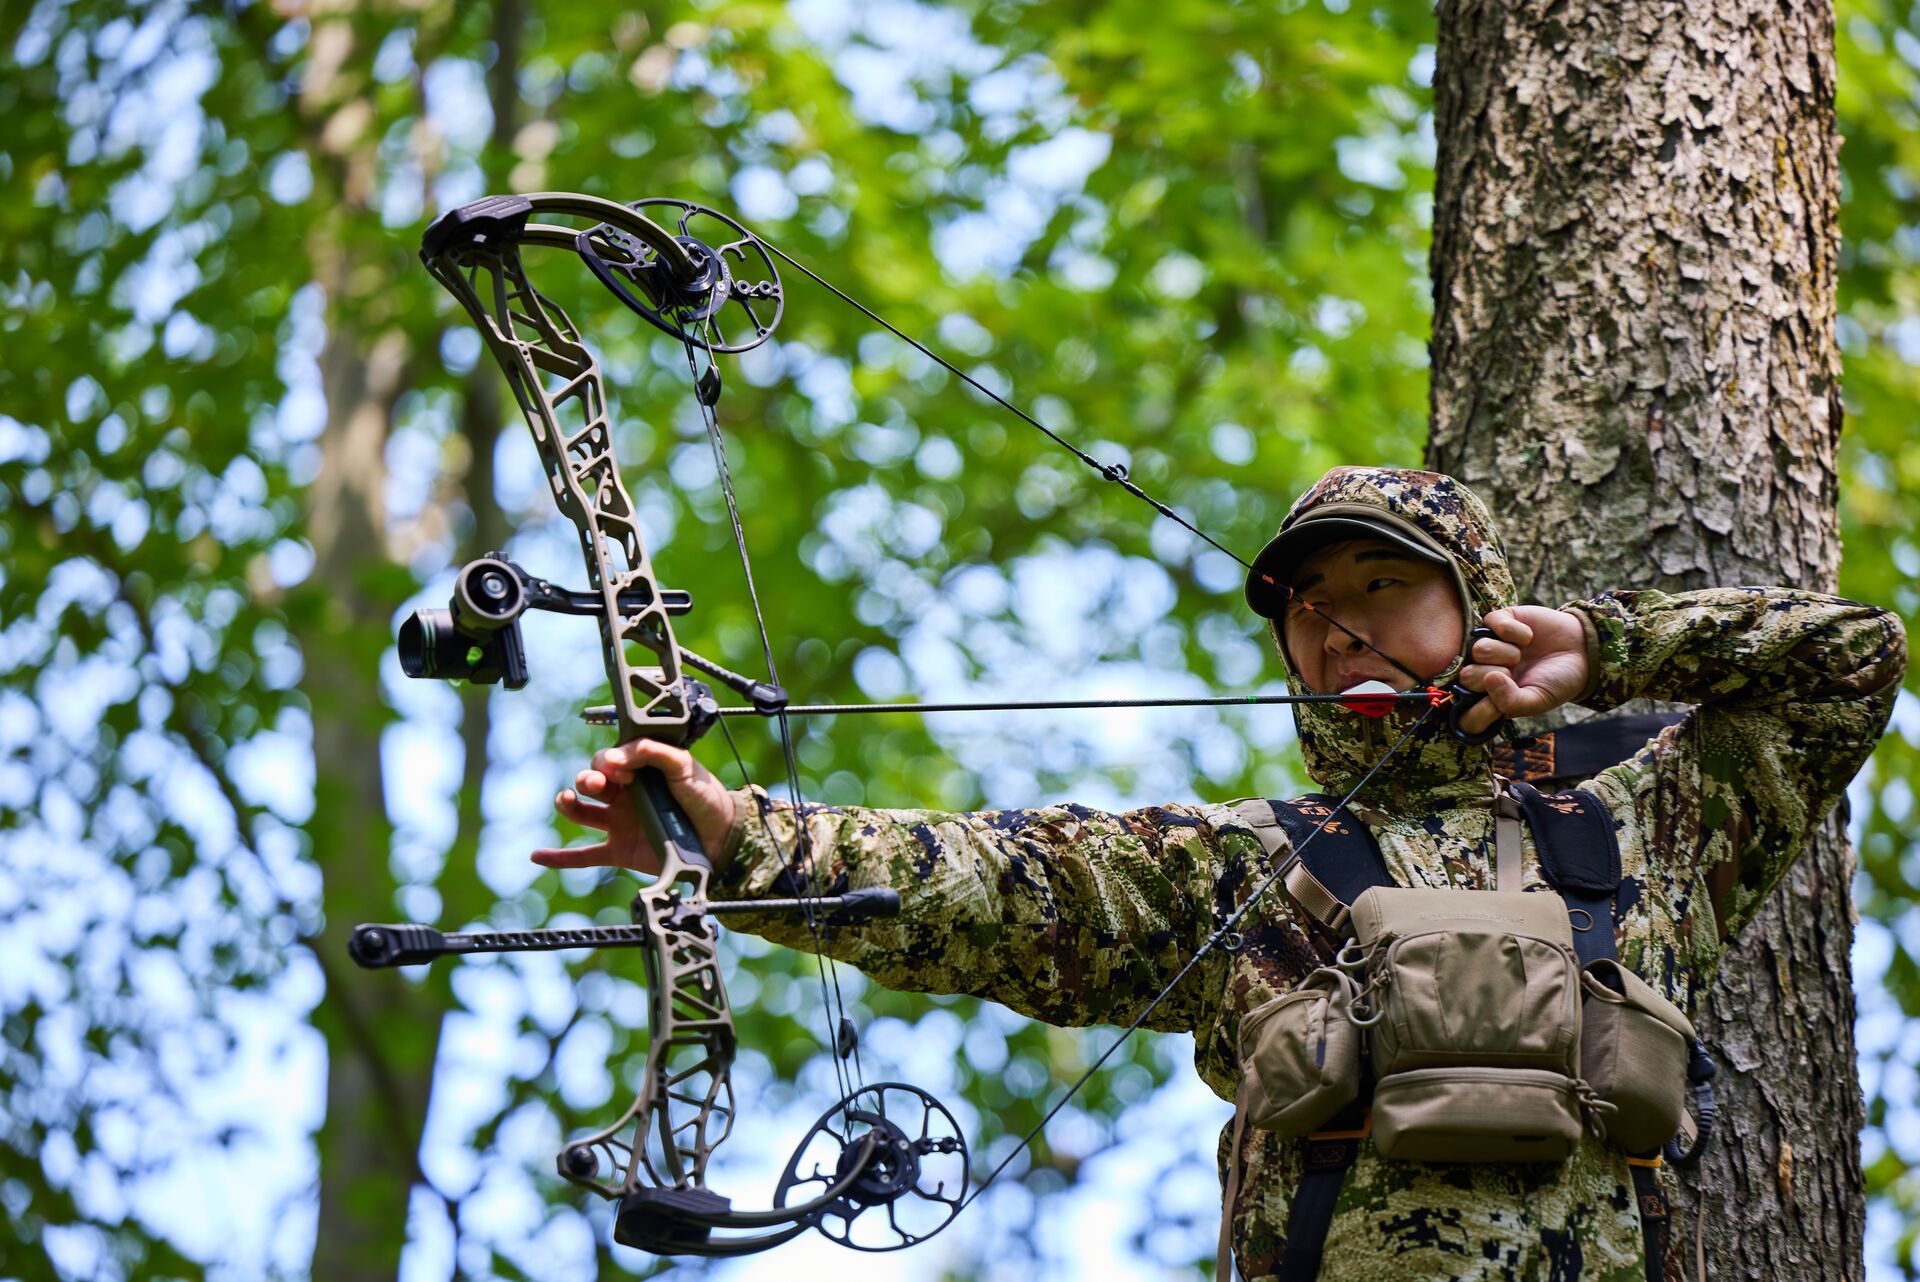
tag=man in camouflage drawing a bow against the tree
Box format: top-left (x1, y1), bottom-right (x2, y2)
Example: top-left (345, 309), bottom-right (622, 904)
top-left (532, 468), bottom-right (1907, 1282)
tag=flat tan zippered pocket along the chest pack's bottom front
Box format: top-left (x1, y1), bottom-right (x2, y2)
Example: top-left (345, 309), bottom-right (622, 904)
top-left (1373, 1069), bottom-right (1580, 1161)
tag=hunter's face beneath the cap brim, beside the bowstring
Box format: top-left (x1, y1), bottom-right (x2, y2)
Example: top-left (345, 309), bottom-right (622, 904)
top-left (1281, 539), bottom-right (1467, 695)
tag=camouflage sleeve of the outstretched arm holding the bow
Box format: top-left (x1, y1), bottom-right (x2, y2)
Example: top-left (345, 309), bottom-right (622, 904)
top-left (714, 789), bottom-right (1258, 1031)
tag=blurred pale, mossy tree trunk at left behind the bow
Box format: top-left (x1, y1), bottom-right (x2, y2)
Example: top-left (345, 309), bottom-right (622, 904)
top-left (294, 13), bottom-right (445, 1282)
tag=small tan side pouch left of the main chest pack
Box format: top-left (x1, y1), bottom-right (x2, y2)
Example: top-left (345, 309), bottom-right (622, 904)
top-left (1240, 967), bottom-right (1359, 1140)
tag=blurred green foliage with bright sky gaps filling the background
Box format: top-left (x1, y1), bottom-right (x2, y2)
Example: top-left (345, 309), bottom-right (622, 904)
top-left (0, 0), bottom-right (1920, 1278)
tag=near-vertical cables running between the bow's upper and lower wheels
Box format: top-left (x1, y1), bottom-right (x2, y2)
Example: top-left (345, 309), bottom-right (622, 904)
top-left (682, 332), bottom-right (866, 1100)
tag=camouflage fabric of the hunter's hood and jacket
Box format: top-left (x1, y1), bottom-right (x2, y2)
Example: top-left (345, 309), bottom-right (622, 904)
top-left (716, 468), bottom-right (1907, 1282)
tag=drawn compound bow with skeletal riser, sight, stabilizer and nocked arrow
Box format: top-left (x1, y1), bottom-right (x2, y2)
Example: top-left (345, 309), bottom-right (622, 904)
top-left (349, 194), bottom-right (1473, 1255)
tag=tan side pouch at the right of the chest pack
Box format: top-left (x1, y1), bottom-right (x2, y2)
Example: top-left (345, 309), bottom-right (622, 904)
top-left (1580, 962), bottom-right (1693, 1153)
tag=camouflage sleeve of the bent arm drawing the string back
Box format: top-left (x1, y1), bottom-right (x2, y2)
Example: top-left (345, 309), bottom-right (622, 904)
top-left (1565, 587), bottom-right (1907, 938)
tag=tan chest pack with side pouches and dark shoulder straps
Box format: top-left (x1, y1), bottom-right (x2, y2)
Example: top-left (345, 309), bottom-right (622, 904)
top-left (1219, 783), bottom-right (1713, 1280)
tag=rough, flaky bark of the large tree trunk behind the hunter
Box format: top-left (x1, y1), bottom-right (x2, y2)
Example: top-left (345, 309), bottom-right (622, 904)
top-left (1428, 0), bottom-right (1864, 1280)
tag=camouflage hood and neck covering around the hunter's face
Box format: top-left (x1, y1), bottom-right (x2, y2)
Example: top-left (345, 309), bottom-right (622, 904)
top-left (1273, 468), bottom-right (1513, 812)
